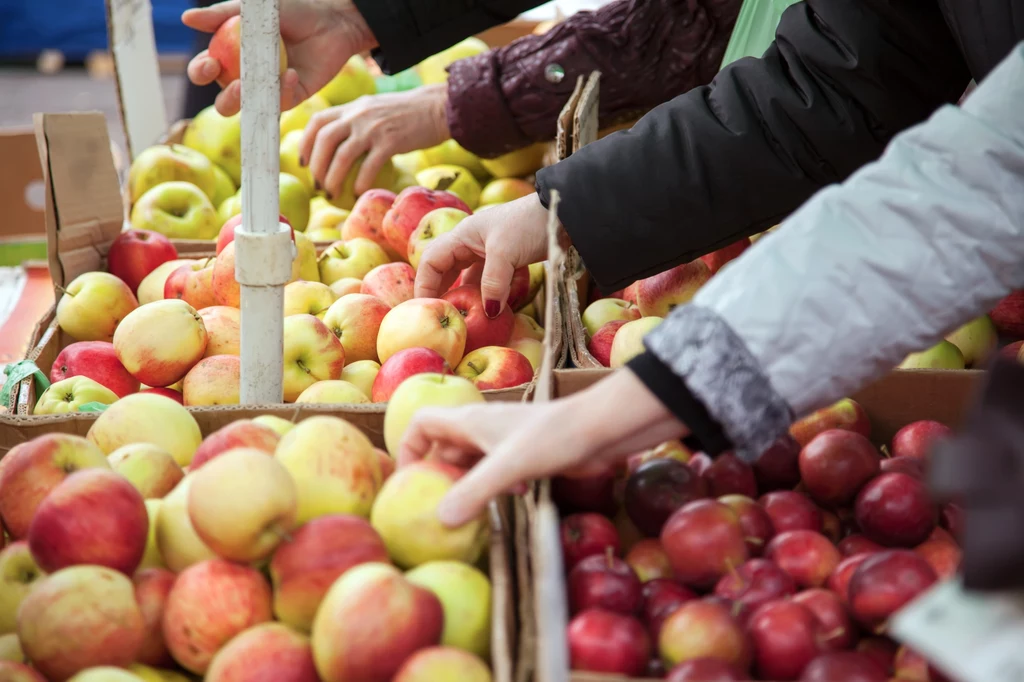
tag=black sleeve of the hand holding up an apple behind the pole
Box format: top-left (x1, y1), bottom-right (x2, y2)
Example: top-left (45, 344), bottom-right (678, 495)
top-left (354, 0), bottom-right (544, 75)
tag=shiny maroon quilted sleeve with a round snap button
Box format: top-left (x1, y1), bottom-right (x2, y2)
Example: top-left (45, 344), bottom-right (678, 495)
top-left (447, 0), bottom-right (741, 158)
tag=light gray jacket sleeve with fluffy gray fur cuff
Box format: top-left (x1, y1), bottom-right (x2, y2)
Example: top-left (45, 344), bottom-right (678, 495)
top-left (646, 43), bottom-right (1024, 459)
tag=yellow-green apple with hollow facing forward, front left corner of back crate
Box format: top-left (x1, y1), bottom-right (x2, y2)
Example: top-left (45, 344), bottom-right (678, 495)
top-left (131, 180), bottom-right (222, 240)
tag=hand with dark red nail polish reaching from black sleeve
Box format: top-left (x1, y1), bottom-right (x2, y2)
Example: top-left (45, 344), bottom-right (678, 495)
top-left (416, 194), bottom-right (568, 317)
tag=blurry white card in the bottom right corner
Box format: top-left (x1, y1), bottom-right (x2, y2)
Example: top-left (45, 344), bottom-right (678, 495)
top-left (889, 580), bottom-right (1024, 682)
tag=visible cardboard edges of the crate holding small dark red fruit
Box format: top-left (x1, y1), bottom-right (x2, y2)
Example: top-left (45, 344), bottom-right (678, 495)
top-left (521, 368), bottom-right (983, 682)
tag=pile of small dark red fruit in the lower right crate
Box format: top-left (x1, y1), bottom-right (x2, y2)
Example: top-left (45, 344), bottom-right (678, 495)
top-left (552, 399), bottom-right (963, 682)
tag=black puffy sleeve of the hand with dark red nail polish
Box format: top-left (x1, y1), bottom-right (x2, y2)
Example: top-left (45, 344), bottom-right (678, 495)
top-left (537, 0), bottom-right (970, 291)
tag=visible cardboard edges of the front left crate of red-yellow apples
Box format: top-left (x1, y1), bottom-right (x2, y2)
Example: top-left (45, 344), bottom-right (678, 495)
top-left (0, 399), bottom-right (524, 682)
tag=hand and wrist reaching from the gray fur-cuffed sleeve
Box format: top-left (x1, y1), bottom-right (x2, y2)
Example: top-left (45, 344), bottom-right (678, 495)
top-left (398, 370), bottom-right (687, 526)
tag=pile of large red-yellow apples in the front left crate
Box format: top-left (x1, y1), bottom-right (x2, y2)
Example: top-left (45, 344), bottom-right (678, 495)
top-left (0, 375), bottom-right (492, 682)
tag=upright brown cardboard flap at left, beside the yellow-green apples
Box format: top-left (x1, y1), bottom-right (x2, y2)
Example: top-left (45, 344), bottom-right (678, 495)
top-left (35, 112), bottom-right (124, 288)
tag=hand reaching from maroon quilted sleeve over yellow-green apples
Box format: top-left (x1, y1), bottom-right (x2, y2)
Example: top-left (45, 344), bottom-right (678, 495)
top-left (299, 83), bottom-right (452, 196)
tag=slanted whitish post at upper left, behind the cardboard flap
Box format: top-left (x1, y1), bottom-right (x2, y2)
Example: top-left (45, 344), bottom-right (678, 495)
top-left (105, 0), bottom-right (167, 159)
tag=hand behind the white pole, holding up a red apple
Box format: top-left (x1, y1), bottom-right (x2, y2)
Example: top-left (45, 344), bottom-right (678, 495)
top-left (181, 0), bottom-right (377, 116)
